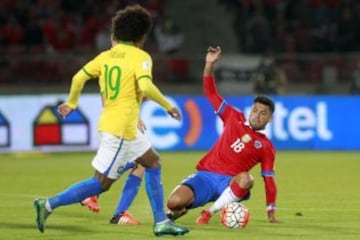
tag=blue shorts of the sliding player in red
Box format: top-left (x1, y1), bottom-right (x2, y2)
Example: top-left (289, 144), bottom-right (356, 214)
top-left (181, 171), bottom-right (250, 209)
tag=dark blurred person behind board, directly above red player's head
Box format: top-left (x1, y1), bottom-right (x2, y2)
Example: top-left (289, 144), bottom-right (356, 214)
top-left (252, 50), bottom-right (287, 95)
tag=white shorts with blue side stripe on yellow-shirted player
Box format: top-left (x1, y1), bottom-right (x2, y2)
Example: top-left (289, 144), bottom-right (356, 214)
top-left (92, 131), bottom-right (151, 179)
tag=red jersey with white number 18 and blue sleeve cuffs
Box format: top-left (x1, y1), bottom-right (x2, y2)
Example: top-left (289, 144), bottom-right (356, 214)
top-left (196, 104), bottom-right (275, 176)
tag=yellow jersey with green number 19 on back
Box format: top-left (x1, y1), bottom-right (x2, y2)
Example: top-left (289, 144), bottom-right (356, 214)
top-left (67, 42), bottom-right (172, 140)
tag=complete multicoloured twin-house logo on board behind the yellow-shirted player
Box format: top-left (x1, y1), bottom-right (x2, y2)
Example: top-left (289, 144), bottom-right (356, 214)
top-left (33, 105), bottom-right (90, 146)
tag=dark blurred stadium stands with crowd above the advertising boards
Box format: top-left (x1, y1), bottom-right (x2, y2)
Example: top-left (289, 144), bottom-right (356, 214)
top-left (0, 0), bottom-right (360, 94)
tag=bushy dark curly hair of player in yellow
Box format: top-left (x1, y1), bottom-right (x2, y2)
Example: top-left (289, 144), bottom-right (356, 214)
top-left (111, 4), bottom-right (152, 43)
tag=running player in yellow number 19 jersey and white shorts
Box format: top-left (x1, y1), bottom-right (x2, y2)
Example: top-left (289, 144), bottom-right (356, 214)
top-left (34, 5), bottom-right (189, 236)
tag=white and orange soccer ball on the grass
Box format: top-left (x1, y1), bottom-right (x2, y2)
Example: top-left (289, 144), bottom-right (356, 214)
top-left (220, 202), bottom-right (250, 228)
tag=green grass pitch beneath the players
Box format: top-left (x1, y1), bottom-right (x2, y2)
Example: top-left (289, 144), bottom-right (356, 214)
top-left (0, 151), bottom-right (360, 240)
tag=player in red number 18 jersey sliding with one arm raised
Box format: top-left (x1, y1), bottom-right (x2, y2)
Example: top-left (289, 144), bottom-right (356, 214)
top-left (167, 47), bottom-right (277, 224)
